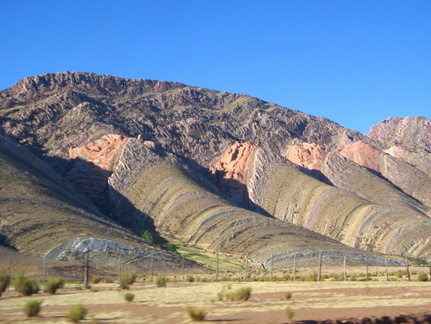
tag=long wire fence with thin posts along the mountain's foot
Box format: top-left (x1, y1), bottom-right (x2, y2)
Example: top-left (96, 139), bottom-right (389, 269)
top-left (0, 250), bottom-right (431, 286)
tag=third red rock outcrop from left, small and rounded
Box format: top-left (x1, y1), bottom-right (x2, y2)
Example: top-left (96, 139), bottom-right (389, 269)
top-left (287, 143), bottom-right (327, 171)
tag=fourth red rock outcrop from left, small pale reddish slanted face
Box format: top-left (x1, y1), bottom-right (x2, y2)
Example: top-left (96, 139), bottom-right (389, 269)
top-left (340, 141), bottom-right (382, 172)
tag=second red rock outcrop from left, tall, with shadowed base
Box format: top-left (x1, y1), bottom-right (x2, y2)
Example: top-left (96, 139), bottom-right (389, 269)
top-left (210, 142), bottom-right (256, 203)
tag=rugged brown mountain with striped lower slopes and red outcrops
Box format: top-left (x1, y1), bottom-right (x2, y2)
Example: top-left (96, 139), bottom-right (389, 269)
top-left (0, 72), bottom-right (431, 266)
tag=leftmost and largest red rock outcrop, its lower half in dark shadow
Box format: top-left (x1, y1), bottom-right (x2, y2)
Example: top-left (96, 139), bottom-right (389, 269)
top-left (65, 134), bottom-right (129, 202)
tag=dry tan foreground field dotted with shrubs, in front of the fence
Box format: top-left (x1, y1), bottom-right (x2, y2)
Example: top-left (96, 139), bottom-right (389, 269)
top-left (0, 281), bottom-right (431, 324)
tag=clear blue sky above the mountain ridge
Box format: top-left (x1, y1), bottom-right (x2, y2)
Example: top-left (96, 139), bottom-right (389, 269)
top-left (0, 0), bottom-right (431, 133)
